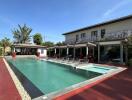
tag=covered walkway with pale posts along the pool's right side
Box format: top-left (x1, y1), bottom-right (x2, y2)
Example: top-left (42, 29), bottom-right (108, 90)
top-left (48, 42), bottom-right (96, 60)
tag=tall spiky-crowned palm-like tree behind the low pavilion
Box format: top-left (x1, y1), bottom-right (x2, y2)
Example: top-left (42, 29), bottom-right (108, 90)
top-left (12, 24), bottom-right (32, 43)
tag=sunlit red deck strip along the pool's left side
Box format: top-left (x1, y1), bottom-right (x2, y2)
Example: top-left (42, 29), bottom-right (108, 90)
top-left (0, 58), bottom-right (21, 100)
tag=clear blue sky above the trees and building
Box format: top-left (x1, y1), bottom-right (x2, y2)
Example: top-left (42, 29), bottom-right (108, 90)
top-left (0, 0), bottom-right (132, 42)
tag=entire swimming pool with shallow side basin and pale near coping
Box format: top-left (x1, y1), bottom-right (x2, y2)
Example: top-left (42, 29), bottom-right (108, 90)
top-left (6, 57), bottom-right (125, 100)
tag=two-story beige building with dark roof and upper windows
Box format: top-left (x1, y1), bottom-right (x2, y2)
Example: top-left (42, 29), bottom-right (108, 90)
top-left (63, 15), bottom-right (132, 63)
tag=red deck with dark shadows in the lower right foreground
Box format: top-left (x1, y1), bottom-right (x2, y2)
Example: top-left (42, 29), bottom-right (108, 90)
top-left (56, 68), bottom-right (132, 100)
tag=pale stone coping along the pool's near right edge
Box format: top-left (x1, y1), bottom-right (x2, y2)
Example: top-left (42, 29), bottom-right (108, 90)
top-left (33, 61), bottom-right (127, 100)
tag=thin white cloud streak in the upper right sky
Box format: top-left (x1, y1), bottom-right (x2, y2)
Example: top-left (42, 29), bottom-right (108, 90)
top-left (103, 0), bottom-right (132, 18)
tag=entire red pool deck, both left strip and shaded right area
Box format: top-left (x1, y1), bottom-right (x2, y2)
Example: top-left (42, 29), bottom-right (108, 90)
top-left (0, 58), bottom-right (132, 100)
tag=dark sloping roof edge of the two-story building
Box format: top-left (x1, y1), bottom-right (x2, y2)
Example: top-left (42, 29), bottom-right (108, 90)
top-left (62, 15), bottom-right (132, 35)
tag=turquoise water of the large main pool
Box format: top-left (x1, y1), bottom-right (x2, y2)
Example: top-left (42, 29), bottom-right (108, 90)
top-left (7, 58), bottom-right (101, 94)
